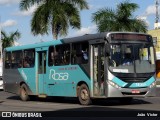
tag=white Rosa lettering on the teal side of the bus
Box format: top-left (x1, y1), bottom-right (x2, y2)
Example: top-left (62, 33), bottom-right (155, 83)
top-left (49, 69), bottom-right (69, 80)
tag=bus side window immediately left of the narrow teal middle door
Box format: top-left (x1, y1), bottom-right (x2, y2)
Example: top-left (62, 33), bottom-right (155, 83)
top-left (23, 49), bottom-right (35, 68)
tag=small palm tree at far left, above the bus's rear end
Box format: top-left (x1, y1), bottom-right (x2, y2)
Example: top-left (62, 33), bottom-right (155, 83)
top-left (1, 30), bottom-right (21, 50)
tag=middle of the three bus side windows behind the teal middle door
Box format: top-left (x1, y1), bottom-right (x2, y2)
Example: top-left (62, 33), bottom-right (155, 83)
top-left (12, 51), bottom-right (23, 69)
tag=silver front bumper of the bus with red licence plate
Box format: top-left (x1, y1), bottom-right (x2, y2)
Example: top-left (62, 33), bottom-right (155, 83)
top-left (107, 85), bottom-right (156, 97)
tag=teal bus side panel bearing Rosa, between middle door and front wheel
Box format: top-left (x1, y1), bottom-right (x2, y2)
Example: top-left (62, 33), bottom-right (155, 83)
top-left (45, 65), bottom-right (91, 97)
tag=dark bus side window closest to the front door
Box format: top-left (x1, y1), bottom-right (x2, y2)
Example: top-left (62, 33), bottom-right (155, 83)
top-left (71, 42), bottom-right (89, 64)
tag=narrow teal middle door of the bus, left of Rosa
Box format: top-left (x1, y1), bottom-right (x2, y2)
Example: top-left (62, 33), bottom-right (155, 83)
top-left (37, 51), bottom-right (46, 95)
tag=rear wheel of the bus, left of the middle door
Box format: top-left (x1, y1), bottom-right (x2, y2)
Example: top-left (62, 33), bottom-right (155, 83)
top-left (20, 84), bottom-right (30, 101)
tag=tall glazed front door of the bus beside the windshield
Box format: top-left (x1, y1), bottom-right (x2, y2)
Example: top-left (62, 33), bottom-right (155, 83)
top-left (91, 44), bottom-right (105, 96)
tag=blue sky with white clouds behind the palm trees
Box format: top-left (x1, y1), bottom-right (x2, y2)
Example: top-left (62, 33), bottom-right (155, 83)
top-left (0, 0), bottom-right (160, 45)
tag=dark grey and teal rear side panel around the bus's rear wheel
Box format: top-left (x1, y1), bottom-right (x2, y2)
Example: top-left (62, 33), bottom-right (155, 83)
top-left (4, 68), bottom-right (35, 94)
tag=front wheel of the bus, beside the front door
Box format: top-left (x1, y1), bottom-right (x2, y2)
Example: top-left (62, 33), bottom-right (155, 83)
top-left (78, 84), bottom-right (92, 105)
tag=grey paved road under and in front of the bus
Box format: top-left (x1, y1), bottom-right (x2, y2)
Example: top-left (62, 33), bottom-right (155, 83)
top-left (0, 88), bottom-right (160, 111)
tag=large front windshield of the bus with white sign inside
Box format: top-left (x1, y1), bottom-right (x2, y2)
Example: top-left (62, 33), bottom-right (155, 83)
top-left (109, 43), bottom-right (155, 73)
